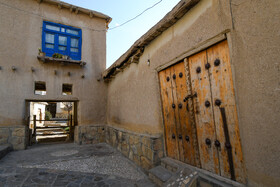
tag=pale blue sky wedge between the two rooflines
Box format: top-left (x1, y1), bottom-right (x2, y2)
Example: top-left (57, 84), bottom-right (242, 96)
top-left (60, 0), bottom-right (180, 67)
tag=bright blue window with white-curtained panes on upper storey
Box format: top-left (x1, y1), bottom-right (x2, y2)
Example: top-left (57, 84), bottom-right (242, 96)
top-left (42, 21), bottom-right (82, 60)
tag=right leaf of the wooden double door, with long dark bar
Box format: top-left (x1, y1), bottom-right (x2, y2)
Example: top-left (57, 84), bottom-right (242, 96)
top-left (188, 41), bottom-right (245, 183)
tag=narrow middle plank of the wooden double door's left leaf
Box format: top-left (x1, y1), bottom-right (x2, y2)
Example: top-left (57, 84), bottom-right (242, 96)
top-left (169, 65), bottom-right (185, 162)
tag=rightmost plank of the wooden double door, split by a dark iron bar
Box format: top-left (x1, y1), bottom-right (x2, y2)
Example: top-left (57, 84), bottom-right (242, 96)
top-left (207, 41), bottom-right (245, 183)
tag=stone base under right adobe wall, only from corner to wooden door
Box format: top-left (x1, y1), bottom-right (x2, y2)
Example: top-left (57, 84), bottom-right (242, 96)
top-left (105, 126), bottom-right (163, 171)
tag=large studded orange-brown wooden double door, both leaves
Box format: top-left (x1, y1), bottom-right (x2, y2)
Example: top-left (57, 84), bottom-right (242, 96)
top-left (159, 41), bottom-right (245, 183)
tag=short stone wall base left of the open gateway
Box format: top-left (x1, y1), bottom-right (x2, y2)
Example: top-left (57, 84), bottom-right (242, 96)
top-left (0, 126), bottom-right (27, 150)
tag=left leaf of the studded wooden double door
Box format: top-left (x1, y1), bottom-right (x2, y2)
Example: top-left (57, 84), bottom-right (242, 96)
top-left (159, 62), bottom-right (199, 166)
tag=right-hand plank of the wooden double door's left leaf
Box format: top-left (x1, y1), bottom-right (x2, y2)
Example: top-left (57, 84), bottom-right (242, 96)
top-left (173, 61), bottom-right (198, 166)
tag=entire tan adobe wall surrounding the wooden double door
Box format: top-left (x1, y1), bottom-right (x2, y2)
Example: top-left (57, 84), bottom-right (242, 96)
top-left (107, 0), bottom-right (280, 186)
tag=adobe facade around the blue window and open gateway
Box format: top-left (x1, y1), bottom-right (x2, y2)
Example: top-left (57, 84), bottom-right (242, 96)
top-left (0, 0), bottom-right (107, 149)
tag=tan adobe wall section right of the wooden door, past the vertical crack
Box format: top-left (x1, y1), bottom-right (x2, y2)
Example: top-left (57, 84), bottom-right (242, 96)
top-left (230, 0), bottom-right (280, 186)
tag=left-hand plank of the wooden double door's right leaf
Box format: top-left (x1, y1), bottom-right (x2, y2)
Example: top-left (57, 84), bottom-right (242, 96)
top-left (188, 51), bottom-right (220, 174)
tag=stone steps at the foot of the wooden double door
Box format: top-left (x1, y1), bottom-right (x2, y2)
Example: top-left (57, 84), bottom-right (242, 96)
top-left (149, 157), bottom-right (244, 187)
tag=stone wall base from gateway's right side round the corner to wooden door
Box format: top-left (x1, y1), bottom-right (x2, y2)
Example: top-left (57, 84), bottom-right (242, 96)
top-left (75, 125), bottom-right (164, 171)
